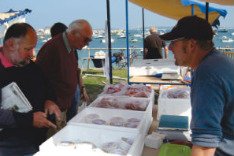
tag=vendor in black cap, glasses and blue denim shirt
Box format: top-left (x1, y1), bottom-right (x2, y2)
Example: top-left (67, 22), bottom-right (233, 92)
top-left (160, 16), bottom-right (234, 156)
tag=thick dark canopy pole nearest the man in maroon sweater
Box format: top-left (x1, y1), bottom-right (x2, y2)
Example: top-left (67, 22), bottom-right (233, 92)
top-left (106, 0), bottom-right (113, 84)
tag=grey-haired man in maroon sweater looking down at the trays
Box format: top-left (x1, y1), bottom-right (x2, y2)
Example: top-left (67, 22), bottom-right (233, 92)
top-left (36, 19), bottom-right (93, 126)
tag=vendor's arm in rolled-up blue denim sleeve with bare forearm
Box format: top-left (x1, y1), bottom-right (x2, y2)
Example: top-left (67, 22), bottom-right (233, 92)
top-left (191, 70), bottom-right (225, 156)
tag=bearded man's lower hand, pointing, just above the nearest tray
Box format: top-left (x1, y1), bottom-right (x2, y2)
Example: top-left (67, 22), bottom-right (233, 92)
top-left (33, 112), bottom-right (57, 129)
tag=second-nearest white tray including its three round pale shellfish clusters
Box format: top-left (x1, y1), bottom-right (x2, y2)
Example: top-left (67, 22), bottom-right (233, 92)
top-left (68, 107), bottom-right (150, 135)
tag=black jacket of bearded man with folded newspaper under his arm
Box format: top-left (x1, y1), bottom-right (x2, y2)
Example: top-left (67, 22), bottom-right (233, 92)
top-left (0, 62), bottom-right (55, 156)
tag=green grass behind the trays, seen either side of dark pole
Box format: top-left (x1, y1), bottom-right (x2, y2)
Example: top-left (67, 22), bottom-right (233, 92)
top-left (82, 69), bottom-right (127, 101)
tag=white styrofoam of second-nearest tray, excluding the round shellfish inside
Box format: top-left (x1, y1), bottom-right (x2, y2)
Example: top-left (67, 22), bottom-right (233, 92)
top-left (68, 107), bottom-right (151, 135)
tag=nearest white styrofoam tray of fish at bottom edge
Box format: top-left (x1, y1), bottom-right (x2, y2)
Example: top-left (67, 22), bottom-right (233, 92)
top-left (38, 125), bottom-right (144, 156)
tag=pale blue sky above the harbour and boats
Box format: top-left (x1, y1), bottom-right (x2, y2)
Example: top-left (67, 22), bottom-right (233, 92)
top-left (0, 0), bottom-right (234, 29)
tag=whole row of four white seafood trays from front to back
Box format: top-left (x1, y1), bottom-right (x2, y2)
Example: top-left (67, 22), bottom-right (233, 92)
top-left (36, 84), bottom-right (154, 156)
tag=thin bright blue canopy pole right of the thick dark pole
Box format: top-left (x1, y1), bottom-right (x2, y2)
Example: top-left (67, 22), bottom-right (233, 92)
top-left (125, 0), bottom-right (130, 84)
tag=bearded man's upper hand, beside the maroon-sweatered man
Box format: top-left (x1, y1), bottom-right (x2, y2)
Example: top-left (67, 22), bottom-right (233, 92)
top-left (45, 100), bottom-right (61, 121)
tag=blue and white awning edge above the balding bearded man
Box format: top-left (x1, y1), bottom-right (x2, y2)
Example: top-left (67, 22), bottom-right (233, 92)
top-left (0, 9), bottom-right (32, 25)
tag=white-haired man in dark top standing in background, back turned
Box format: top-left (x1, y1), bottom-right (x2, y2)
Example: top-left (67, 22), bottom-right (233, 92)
top-left (144, 26), bottom-right (168, 59)
